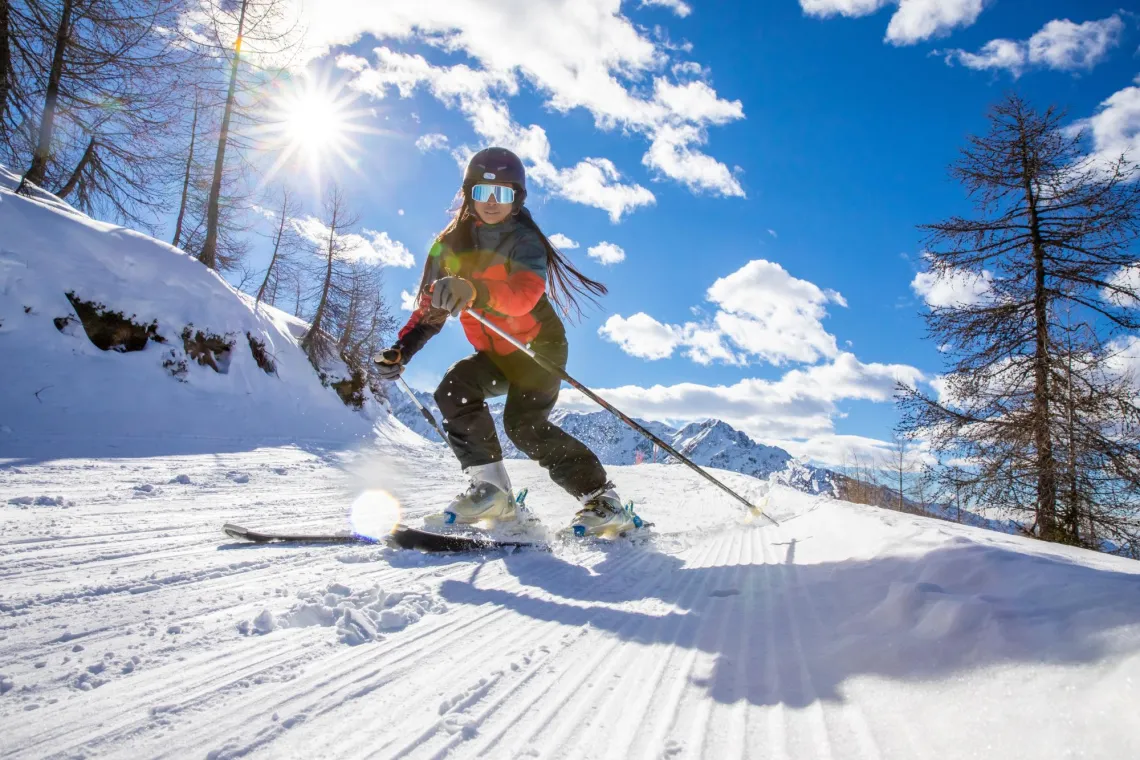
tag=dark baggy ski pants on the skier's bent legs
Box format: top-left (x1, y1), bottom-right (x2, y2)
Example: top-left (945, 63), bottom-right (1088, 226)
top-left (435, 343), bottom-right (606, 498)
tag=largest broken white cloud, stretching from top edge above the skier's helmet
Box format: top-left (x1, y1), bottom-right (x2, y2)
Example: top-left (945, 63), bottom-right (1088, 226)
top-left (296, 0), bottom-right (743, 220)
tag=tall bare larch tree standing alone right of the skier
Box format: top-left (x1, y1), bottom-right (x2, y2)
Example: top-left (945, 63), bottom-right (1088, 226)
top-left (898, 95), bottom-right (1140, 553)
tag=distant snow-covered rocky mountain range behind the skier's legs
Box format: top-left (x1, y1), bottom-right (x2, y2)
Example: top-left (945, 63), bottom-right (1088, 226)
top-left (389, 386), bottom-right (834, 496)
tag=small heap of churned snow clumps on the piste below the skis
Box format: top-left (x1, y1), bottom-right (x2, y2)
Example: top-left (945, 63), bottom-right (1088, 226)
top-left (249, 583), bottom-right (447, 646)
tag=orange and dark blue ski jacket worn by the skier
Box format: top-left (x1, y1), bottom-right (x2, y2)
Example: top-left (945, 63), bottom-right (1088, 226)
top-left (396, 209), bottom-right (565, 363)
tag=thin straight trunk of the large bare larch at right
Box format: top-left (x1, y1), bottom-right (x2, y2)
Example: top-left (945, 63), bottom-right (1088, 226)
top-left (1021, 126), bottom-right (1057, 541)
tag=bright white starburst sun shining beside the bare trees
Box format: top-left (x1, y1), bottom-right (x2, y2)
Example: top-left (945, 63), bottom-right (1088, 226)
top-left (257, 76), bottom-right (380, 182)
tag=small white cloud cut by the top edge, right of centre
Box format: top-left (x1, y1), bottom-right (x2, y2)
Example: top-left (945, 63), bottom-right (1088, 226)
top-left (799, 0), bottom-right (985, 44)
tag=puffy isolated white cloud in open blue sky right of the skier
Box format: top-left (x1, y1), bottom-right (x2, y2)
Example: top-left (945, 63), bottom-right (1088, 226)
top-left (599, 259), bottom-right (847, 365)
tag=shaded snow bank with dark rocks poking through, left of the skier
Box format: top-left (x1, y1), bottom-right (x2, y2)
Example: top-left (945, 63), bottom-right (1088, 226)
top-left (0, 167), bottom-right (378, 457)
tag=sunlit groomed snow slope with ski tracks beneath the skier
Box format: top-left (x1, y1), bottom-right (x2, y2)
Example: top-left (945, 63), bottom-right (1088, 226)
top-left (0, 439), bottom-right (1140, 760)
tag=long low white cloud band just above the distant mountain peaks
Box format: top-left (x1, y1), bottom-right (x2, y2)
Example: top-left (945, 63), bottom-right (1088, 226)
top-left (559, 353), bottom-right (922, 453)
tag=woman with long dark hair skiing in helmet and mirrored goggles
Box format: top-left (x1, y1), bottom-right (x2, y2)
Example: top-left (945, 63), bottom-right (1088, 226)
top-left (376, 148), bottom-right (634, 536)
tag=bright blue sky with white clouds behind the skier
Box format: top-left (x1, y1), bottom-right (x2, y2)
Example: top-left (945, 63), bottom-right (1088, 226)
top-left (231, 0), bottom-right (1140, 463)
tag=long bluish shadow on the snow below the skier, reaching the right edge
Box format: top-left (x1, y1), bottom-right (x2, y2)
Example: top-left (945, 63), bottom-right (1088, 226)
top-left (441, 538), bottom-right (1140, 706)
